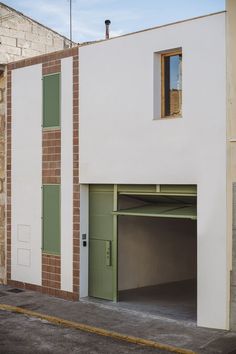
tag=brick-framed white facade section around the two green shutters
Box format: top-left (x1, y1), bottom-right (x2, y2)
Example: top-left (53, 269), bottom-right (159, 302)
top-left (7, 48), bottom-right (79, 299)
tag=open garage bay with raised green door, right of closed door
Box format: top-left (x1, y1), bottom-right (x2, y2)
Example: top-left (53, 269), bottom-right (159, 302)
top-left (116, 192), bottom-right (197, 321)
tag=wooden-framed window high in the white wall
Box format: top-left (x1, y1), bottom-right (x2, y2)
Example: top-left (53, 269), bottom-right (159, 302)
top-left (161, 51), bottom-right (182, 118)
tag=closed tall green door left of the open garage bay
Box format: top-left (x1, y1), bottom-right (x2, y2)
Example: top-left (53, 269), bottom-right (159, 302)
top-left (89, 185), bottom-right (116, 300)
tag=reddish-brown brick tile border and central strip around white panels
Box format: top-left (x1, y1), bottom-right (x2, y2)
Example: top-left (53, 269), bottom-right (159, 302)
top-left (7, 47), bottom-right (80, 300)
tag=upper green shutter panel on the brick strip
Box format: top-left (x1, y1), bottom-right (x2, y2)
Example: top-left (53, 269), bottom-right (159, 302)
top-left (43, 73), bottom-right (61, 128)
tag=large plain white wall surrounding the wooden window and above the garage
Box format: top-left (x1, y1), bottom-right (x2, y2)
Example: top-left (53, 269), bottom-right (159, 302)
top-left (80, 13), bottom-right (229, 328)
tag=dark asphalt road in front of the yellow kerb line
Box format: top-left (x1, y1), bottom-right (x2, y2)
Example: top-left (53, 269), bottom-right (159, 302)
top-left (0, 311), bottom-right (171, 354)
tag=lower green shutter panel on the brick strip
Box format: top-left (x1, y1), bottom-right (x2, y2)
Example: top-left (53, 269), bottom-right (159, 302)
top-left (43, 184), bottom-right (61, 254)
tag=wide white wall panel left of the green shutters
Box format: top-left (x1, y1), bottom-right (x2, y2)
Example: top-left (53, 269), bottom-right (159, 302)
top-left (11, 65), bottom-right (42, 285)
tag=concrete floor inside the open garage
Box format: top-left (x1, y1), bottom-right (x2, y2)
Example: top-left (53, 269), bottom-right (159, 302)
top-left (119, 280), bottom-right (197, 322)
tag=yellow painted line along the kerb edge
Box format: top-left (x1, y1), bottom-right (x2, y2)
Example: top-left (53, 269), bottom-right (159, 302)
top-left (0, 304), bottom-right (196, 354)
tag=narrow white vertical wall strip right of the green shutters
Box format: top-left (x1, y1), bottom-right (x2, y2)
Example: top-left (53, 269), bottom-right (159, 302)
top-left (61, 57), bottom-right (73, 292)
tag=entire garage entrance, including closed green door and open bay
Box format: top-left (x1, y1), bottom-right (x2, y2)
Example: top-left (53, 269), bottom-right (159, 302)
top-left (88, 185), bottom-right (197, 321)
